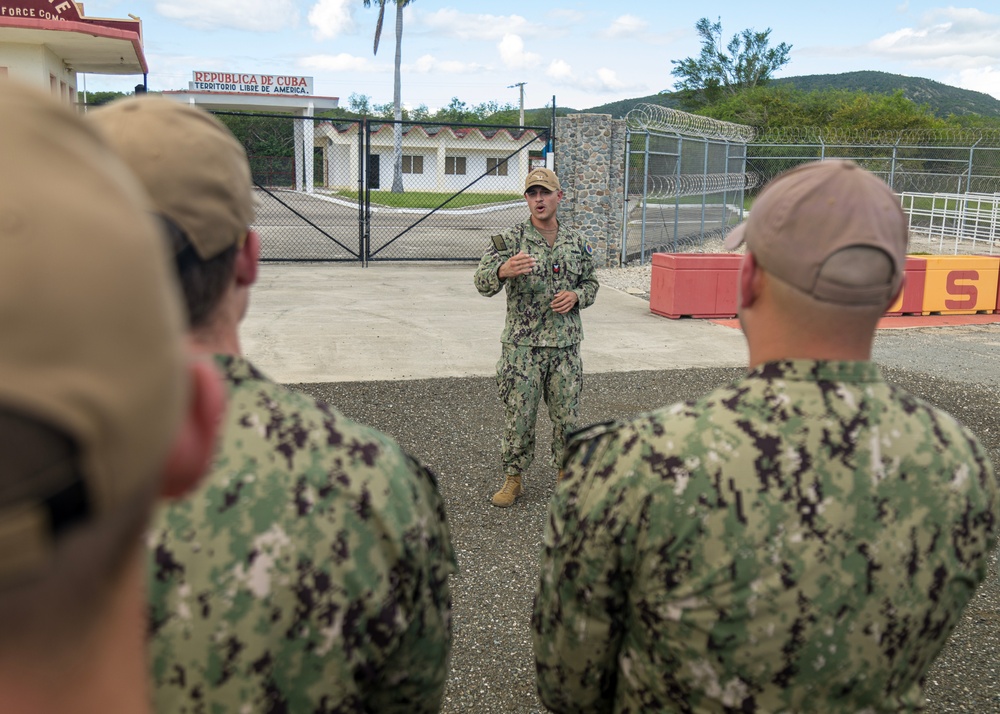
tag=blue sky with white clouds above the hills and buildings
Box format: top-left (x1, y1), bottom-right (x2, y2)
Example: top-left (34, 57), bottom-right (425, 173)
top-left (80, 0), bottom-right (1000, 111)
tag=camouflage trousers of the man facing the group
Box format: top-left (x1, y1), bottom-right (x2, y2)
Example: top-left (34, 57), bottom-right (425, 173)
top-left (497, 344), bottom-right (583, 474)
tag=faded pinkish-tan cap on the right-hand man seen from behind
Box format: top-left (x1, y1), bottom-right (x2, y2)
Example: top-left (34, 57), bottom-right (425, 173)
top-left (725, 160), bottom-right (908, 305)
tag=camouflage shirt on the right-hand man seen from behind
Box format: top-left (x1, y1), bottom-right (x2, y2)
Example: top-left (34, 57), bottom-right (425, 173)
top-left (533, 360), bottom-right (1000, 714)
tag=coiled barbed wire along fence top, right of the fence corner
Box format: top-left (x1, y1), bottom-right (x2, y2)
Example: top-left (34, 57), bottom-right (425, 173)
top-left (754, 126), bottom-right (1000, 147)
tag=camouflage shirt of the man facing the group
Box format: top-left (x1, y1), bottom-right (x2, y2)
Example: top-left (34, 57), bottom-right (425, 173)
top-left (474, 221), bottom-right (598, 347)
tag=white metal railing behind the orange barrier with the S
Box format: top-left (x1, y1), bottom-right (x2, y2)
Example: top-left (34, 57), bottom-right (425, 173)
top-left (900, 193), bottom-right (1000, 255)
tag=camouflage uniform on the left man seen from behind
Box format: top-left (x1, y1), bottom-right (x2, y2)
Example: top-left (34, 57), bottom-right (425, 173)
top-left (149, 356), bottom-right (455, 714)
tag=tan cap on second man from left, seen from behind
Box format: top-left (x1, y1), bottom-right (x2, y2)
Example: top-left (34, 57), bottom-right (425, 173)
top-left (87, 94), bottom-right (254, 260)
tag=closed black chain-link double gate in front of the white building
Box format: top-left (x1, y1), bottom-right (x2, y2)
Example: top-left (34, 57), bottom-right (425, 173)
top-left (218, 112), bottom-right (551, 263)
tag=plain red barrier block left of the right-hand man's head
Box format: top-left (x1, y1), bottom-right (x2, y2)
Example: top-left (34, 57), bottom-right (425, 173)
top-left (649, 253), bottom-right (743, 318)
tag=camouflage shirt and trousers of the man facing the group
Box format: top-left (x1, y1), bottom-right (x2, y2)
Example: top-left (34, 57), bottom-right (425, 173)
top-left (475, 221), bottom-right (598, 475)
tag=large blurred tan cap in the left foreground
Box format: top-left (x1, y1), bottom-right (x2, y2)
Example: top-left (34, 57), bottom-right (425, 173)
top-left (0, 80), bottom-right (188, 589)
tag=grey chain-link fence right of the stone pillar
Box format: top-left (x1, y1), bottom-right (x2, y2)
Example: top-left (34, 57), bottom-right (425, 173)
top-left (623, 105), bottom-right (1000, 262)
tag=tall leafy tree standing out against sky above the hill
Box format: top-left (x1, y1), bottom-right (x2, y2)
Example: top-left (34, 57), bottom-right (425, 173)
top-left (670, 17), bottom-right (792, 109)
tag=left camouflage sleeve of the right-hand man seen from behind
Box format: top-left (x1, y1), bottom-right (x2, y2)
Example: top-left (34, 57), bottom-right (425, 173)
top-left (532, 426), bottom-right (646, 712)
